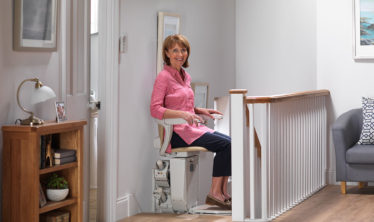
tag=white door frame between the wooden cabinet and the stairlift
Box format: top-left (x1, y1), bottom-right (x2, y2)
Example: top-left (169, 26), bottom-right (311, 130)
top-left (59, 0), bottom-right (119, 219)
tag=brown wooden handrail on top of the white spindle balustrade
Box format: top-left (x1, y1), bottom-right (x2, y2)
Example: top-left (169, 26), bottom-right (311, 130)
top-left (244, 89), bottom-right (330, 104)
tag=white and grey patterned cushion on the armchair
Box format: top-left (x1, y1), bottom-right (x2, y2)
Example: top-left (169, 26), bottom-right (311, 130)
top-left (357, 97), bottom-right (374, 145)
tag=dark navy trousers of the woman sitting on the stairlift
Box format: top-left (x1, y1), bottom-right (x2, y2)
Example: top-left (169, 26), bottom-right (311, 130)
top-left (170, 132), bottom-right (231, 177)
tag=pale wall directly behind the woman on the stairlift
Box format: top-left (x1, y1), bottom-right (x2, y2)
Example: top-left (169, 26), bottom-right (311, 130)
top-left (117, 0), bottom-right (235, 218)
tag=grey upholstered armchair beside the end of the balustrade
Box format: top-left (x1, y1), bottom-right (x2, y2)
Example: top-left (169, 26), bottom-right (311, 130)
top-left (332, 109), bottom-right (374, 194)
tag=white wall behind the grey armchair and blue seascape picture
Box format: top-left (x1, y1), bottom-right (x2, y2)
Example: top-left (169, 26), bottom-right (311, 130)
top-left (317, 0), bottom-right (374, 182)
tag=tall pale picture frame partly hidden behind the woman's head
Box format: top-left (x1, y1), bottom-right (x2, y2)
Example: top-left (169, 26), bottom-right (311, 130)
top-left (156, 12), bottom-right (181, 75)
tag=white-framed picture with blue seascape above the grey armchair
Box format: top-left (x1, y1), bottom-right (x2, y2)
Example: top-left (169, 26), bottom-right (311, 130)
top-left (353, 0), bottom-right (374, 59)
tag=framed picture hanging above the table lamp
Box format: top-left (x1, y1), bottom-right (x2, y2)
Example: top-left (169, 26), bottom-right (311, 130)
top-left (13, 0), bottom-right (60, 52)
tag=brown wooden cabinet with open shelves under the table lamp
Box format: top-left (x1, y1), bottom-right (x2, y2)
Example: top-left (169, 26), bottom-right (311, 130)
top-left (2, 121), bottom-right (86, 222)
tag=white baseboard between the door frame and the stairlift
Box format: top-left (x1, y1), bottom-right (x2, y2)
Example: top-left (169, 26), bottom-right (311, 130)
top-left (116, 194), bottom-right (141, 221)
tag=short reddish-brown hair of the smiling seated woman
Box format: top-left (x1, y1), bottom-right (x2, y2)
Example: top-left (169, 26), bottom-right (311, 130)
top-left (162, 34), bottom-right (191, 68)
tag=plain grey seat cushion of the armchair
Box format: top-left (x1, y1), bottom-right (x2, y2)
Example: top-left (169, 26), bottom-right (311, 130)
top-left (346, 144), bottom-right (374, 164)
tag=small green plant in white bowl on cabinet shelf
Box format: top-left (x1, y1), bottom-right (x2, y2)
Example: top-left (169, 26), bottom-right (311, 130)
top-left (47, 173), bottom-right (69, 201)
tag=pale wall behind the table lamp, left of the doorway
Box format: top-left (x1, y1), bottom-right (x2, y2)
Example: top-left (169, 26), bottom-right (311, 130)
top-left (0, 1), bottom-right (60, 217)
